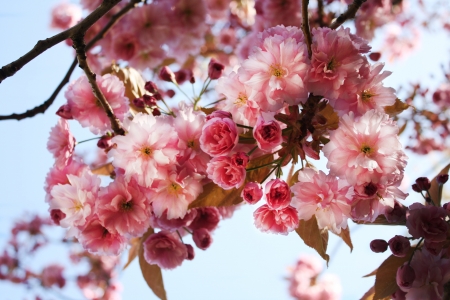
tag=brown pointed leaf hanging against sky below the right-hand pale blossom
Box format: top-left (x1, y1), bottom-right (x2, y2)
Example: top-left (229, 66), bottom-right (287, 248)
top-left (295, 215), bottom-right (330, 264)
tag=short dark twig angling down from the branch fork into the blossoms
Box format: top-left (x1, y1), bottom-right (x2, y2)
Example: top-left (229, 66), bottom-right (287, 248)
top-left (72, 32), bottom-right (125, 135)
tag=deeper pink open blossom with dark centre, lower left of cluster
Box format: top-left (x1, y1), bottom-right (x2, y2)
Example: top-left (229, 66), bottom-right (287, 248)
top-left (95, 176), bottom-right (150, 236)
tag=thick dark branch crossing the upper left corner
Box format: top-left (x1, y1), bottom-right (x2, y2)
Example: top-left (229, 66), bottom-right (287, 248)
top-left (0, 0), bottom-right (120, 83)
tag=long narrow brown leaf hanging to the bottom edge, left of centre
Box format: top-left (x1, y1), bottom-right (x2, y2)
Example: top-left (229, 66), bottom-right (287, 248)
top-left (139, 227), bottom-right (167, 300)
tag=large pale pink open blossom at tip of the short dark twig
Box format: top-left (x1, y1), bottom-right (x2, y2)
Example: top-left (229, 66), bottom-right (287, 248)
top-left (108, 113), bottom-right (179, 187)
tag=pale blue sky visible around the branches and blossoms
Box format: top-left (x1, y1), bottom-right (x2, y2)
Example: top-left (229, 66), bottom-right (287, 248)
top-left (0, 0), bottom-right (450, 300)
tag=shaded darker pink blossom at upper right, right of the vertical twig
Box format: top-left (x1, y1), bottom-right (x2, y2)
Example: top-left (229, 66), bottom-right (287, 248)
top-left (306, 27), bottom-right (365, 104)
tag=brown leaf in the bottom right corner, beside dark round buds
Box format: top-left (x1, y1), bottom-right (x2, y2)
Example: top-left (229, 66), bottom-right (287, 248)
top-left (374, 247), bottom-right (414, 300)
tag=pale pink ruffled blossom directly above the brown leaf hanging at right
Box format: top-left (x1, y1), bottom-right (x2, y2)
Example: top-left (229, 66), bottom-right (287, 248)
top-left (291, 168), bottom-right (351, 234)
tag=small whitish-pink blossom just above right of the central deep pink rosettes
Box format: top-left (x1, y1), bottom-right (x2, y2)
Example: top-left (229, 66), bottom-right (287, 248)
top-left (216, 72), bottom-right (264, 126)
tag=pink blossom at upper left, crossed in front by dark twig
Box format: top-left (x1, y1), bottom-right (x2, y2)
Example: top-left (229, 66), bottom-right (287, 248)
top-left (65, 74), bottom-right (129, 134)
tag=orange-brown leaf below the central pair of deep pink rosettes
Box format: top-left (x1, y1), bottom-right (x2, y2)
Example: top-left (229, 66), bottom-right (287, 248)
top-left (189, 154), bottom-right (273, 208)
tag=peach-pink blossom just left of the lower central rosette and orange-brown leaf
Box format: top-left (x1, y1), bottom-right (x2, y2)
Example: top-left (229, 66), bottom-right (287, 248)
top-left (149, 170), bottom-right (203, 220)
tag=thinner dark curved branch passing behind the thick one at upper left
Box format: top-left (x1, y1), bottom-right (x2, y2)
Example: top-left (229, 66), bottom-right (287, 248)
top-left (0, 0), bottom-right (143, 121)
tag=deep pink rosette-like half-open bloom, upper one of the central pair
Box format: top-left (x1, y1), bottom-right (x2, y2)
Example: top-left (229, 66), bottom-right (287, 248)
top-left (200, 117), bottom-right (239, 157)
